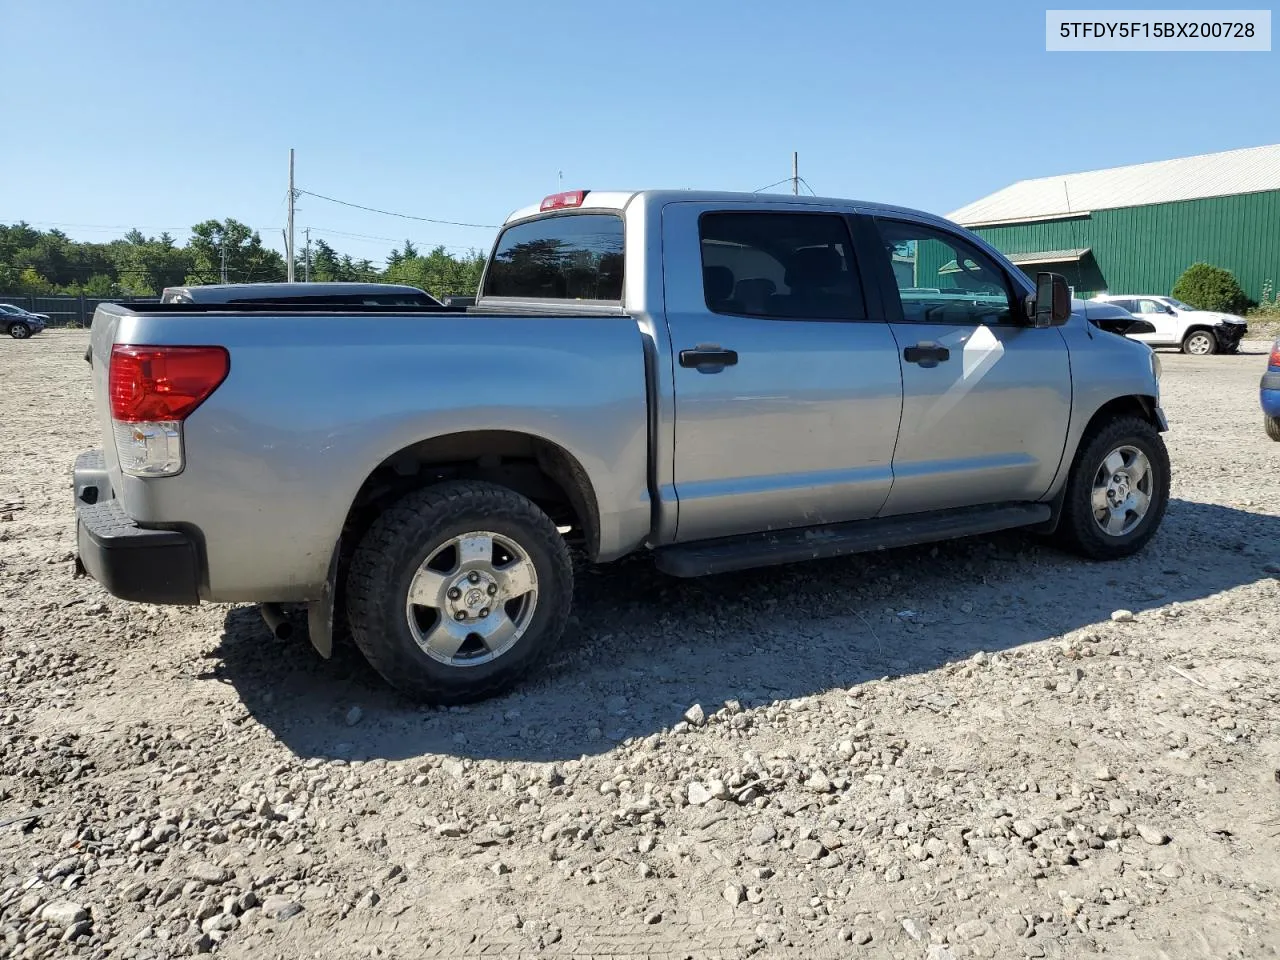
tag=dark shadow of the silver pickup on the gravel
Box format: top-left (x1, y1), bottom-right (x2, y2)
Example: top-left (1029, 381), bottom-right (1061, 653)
top-left (212, 499), bottom-right (1280, 762)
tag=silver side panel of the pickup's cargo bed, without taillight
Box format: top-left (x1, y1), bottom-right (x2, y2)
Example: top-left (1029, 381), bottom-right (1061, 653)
top-left (91, 303), bottom-right (650, 600)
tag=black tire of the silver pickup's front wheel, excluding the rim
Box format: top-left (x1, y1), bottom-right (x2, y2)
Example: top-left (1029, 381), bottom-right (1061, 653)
top-left (1056, 416), bottom-right (1170, 561)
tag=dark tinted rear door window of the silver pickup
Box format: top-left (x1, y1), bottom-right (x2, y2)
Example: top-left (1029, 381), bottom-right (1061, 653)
top-left (699, 212), bottom-right (867, 320)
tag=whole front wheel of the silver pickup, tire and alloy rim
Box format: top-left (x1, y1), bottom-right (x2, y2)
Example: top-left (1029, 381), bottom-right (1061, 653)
top-left (1057, 417), bottom-right (1169, 559)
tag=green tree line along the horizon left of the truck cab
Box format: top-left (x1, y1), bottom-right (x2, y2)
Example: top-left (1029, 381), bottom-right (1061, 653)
top-left (0, 219), bottom-right (485, 297)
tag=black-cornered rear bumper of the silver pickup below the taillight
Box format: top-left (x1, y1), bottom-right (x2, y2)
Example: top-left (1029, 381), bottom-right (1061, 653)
top-left (72, 451), bottom-right (200, 605)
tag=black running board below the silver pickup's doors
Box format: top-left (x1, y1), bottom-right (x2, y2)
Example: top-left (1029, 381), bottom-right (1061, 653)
top-left (654, 503), bottom-right (1052, 577)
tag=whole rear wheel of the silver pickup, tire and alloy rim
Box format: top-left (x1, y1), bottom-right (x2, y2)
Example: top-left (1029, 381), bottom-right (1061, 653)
top-left (347, 481), bottom-right (573, 704)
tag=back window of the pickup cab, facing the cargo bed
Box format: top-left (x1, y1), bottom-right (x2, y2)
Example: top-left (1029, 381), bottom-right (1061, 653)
top-left (484, 214), bottom-right (623, 302)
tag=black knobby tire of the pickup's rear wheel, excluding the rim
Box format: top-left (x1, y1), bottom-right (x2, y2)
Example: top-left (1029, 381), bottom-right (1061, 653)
top-left (346, 480), bottom-right (573, 704)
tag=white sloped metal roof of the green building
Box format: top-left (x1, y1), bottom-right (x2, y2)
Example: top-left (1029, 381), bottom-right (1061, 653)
top-left (947, 143), bottom-right (1280, 227)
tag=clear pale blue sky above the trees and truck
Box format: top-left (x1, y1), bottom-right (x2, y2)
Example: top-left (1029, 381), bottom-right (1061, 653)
top-left (0, 0), bottom-right (1280, 261)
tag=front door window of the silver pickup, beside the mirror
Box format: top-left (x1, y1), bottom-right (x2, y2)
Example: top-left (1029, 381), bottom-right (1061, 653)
top-left (876, 218), bottom-right (1014, 325)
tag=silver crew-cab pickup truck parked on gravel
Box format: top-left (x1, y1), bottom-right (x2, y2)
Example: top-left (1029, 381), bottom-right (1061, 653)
top-left (74, 191), bottom-right (1170, 703)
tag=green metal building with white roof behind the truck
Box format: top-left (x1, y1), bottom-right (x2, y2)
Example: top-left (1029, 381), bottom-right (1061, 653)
top-left (947, 145), bottom-right (1280, 300)
